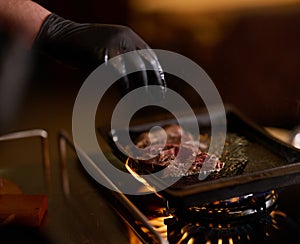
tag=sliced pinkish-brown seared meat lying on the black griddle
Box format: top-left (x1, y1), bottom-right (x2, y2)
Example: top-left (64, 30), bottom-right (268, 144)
top-left (136, 125), bottom-right (224, 177)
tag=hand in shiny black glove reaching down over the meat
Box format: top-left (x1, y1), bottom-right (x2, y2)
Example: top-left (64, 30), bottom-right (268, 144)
top-left (33, 14), bottom-right (166, 92)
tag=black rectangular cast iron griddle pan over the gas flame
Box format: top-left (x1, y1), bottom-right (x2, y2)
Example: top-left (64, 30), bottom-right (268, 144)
top-left (99, 108), bottom-right (300, 207)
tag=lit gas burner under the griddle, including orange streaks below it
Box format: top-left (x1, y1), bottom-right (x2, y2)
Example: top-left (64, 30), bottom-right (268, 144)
top-left (164, 191), bottom-right (296, 244)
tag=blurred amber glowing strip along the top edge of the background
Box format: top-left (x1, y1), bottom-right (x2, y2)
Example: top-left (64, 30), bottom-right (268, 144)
top-left (130, 0), bottom-right (300, 13)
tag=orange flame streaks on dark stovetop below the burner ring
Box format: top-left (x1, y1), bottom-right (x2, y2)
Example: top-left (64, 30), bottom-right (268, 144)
top-left (165, 211), bottom-right (288, 244)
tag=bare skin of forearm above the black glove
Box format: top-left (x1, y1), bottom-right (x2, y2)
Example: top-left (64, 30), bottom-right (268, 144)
top-left (0, 0), bottom-right (50, 45)
